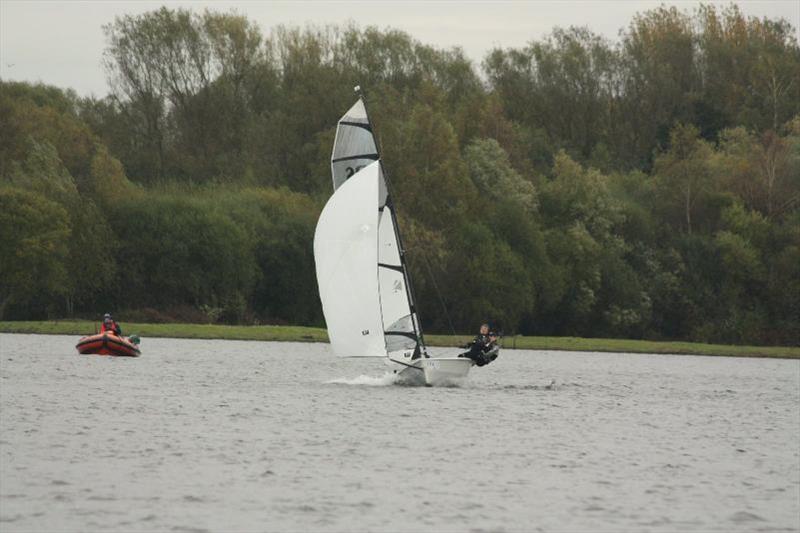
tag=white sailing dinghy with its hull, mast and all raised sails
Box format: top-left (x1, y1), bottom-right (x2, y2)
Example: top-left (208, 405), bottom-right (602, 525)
top-left (314, 87), bottom-right (473, 385)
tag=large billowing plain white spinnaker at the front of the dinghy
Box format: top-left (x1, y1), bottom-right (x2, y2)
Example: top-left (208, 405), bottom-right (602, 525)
top-left (314, 163), bottom-right (386, 357)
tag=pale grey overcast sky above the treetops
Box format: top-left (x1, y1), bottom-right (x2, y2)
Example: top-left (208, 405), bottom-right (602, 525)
top-left (0, 0), bottom-right (800, 96)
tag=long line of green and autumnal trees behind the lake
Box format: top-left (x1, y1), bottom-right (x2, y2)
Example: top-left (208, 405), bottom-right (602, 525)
top-left (0, 5), bottom-right (800, 345)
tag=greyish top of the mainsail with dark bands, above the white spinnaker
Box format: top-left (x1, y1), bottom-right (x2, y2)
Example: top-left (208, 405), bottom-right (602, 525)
top-left (331, 99), bottom-right (378, 191)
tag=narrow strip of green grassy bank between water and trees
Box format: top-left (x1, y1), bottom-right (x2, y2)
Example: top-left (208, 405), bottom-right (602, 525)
top-left (0, 320), bottom-right (800, 359)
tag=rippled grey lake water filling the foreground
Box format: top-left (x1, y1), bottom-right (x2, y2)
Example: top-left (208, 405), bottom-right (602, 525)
top-left (0, 335), bottom-right (800, 532)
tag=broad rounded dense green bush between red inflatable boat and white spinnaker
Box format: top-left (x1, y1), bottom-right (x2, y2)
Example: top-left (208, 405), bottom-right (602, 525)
top-left (110, 193), bottom-right (255, 318)
